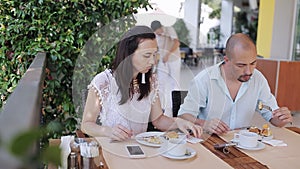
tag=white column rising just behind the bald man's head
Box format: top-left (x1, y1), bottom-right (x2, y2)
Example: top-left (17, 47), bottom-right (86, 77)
top-left (220, 0), bottom-right (233, 47)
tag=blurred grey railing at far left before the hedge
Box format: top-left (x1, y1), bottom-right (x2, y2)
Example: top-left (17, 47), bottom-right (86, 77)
top-left (0, 53), bottom-right (46, 169)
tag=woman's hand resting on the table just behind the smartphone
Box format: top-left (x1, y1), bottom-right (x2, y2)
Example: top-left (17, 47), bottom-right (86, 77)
top-left (110, 124), bottom-right (133, 141)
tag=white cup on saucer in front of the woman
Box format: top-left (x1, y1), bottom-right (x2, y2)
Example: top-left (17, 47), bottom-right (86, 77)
top-left (168, 139), bottom-right (187, 156)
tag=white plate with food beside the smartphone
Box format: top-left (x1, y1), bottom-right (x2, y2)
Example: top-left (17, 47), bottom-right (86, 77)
top-left (135, 131), bottom-right (166, 147)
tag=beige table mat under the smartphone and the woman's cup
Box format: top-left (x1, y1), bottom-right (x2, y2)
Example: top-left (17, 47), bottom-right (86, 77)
top-left (96, 137), bottom-right (232, 169)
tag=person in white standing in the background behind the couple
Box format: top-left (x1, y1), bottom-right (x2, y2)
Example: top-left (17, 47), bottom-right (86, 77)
top-left (151, 20), bottom-right (181, 116)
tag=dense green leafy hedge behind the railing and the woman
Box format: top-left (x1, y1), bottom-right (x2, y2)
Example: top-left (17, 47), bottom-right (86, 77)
top-left (0, 0), bottom-right (150, 138)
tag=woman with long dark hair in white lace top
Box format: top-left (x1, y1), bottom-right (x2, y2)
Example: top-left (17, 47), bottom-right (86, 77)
top-left (81, 26), bottom-right (202, 140)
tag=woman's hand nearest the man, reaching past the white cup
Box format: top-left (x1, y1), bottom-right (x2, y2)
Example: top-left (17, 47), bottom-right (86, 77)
top-left (175, 118), bottom-right (203, 138)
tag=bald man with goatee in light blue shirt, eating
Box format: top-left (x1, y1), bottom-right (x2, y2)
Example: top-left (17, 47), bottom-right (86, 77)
top-left (178, 33), bottom-right (293, 134)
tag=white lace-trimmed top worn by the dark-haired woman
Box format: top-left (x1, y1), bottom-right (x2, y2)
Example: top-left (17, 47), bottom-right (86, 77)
top-left (88, 69), bottom-right (158, 134)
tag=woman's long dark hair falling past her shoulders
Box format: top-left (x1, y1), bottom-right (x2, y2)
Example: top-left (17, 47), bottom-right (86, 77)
top-left (111, 26), bottom-right (155, 105)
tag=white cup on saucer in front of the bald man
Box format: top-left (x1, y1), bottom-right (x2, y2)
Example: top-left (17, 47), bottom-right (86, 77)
top-left (234, 131), bottom-right (258, 148)
